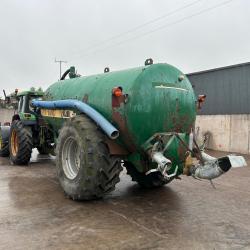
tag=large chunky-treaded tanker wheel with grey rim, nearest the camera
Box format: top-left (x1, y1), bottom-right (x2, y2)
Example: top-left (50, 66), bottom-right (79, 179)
top-left (56, 115), bottom-right (122, 200)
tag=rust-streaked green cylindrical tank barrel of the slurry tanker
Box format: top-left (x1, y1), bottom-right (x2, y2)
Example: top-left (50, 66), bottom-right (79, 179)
top-left (45, 64), bottom-right (196, 151)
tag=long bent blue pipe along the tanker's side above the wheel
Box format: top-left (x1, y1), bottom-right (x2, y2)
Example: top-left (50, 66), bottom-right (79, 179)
top-left (32, 99), bottom-right (119, 139)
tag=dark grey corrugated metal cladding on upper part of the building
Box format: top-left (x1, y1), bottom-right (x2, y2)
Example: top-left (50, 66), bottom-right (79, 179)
top-left (187, 63), bottom-right (250, 115)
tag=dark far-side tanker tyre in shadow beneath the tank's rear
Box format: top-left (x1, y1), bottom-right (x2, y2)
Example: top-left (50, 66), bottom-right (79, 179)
top-left (124, 161), bottom-right (172, 188)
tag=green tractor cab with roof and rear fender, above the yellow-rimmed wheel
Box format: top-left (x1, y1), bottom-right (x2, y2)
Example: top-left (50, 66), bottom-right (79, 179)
top-left (16, 91), bottom-right (43, 125)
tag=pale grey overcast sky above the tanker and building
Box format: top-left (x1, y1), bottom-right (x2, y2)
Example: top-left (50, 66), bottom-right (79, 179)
top-left (0, 0), bottom-right (250, 96)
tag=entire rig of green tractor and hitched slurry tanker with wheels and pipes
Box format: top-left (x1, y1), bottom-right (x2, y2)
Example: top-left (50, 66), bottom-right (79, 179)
top-left (0, 59), bottom-right (245, 200)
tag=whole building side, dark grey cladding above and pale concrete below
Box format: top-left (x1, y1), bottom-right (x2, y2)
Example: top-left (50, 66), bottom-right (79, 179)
top-left (187, 63), bottom-right (250, 154)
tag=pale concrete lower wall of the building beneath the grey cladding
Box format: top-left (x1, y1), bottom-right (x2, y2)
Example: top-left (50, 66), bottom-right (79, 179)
top-left (196, 115), bottom-right (250, 154)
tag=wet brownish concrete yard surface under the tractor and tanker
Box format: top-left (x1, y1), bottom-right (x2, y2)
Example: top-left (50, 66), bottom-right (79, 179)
top-left (0, 152), bottom-right (250, 250)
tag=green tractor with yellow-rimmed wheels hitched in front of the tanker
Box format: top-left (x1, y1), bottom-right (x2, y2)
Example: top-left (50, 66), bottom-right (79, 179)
top-left (0, 91), bottom-right (53, 162)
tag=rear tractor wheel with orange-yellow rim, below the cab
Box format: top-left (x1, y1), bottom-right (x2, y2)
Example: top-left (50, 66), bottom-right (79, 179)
top-left (9, 120), bottom-right (33, 165)
